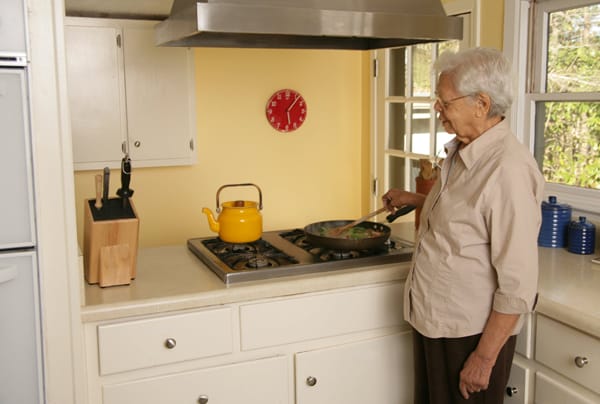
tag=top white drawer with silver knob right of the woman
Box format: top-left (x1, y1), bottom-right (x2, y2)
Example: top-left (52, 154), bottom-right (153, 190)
top-left (535, 315), bottom-right (600, 393)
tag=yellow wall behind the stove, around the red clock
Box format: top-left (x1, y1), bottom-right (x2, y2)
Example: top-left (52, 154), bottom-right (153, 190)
top-left (75, 49), bottom-right (369, 247)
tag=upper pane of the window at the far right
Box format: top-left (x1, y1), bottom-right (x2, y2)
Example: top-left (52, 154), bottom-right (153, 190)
top-left (546, 4), bottom-right (600, 92)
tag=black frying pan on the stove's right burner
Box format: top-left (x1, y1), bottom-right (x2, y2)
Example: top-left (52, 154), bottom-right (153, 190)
top-left (304, 205), bottom-right (415, 251)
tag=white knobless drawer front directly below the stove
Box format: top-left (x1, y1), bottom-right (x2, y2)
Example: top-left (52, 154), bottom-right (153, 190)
top-left (240, 283), bottom-right (405, 350)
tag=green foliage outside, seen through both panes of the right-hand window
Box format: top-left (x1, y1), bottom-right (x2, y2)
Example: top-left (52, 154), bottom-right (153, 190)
top-left (538, 5), bottom-right (600, 189)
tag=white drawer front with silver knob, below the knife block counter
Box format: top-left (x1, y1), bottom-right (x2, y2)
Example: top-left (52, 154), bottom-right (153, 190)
top-left (98, 308), bottom-right (233, 375)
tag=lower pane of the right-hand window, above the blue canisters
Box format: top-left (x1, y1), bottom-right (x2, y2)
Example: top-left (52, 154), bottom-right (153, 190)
top-left (535, 102), bottom-right (600, 189)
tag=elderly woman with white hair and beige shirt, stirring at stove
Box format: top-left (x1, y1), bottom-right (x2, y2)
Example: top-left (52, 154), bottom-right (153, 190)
top-left (383, 48), bottom-right (544, 404)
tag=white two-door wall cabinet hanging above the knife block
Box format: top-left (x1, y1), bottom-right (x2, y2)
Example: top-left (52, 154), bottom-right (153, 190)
top-left (65, 17), bottom-right (196, 170)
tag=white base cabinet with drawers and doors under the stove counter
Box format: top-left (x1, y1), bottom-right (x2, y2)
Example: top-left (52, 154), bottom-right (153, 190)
top-left (85, 282), bottom-right (413, 404)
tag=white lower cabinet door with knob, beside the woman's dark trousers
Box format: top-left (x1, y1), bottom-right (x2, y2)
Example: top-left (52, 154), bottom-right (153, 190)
top-left (296, 332), bottom-right (413, 404)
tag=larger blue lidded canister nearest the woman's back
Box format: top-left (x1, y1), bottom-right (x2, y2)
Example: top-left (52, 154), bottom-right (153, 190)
top-left (538, 196), bottom-right (572, 248)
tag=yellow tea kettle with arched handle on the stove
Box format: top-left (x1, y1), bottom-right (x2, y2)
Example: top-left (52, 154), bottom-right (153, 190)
top-left (202, 183), bottom-right (262, 243)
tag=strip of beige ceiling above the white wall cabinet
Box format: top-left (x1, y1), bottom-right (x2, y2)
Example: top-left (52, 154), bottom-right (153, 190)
top-left (65, 0), bottom-right (173, 20)
